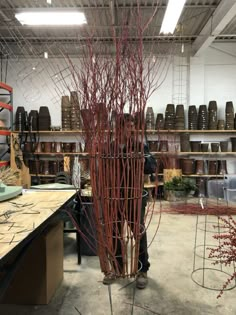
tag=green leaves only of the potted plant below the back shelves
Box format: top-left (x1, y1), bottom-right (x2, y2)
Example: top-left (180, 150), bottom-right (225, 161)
top-left (164, 177), bottom-right (197, 193)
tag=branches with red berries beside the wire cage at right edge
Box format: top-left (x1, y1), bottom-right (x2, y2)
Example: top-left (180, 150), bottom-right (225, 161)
top-left (209, 216), bottom-right (236, 298)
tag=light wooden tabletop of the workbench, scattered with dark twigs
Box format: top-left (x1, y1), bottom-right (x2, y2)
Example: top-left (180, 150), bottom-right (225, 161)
top-left (0, 190), bottom-right (75, 263)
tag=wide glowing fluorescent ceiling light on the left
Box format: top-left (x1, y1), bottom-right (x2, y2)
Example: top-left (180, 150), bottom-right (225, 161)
top-left (15, 10), bottom-right (87, 25)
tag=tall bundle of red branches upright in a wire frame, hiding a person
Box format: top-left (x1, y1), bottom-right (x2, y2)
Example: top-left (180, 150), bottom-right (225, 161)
top-left (62, 1), bottom-right (168, 277)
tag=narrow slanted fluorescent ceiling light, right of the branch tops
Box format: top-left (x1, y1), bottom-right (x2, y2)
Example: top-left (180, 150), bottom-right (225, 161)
top-left (160, 0), bottom-right (186, 34)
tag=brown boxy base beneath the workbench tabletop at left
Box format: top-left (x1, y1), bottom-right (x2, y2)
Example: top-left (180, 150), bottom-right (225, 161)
top-left (1, 222), bottom-right (64, 304)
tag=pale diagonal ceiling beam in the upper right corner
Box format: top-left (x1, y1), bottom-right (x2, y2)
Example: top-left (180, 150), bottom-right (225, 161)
top-left (192, 0), bottom-right (236, 56)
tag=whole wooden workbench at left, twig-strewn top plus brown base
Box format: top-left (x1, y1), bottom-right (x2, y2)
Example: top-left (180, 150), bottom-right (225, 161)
top-left (0, 190), bottom-right (75, 304)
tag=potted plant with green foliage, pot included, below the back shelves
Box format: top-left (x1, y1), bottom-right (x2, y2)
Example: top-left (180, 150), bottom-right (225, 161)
top-left (164, 177), bottom-right (197, 201)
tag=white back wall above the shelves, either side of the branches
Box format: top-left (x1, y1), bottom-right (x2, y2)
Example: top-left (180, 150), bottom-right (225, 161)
top-left (7, 44), bottom-right (236, 125)
